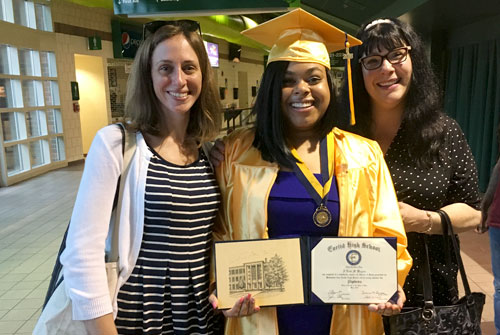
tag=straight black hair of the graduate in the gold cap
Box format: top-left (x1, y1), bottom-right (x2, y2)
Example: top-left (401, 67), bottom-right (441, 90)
top-left (252, 61), bottom-right (337, 168)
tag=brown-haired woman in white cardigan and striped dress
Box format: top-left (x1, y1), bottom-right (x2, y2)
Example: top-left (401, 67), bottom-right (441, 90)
top-left (61, 20), bottom-right (220, 334)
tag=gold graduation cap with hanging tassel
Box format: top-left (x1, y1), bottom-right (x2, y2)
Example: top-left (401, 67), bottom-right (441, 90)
top-left (241, 8), bottom-right (361, 124)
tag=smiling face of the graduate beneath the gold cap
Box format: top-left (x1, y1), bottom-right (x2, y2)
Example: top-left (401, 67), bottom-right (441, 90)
top-left (281, 62), bottom-right (330, 134)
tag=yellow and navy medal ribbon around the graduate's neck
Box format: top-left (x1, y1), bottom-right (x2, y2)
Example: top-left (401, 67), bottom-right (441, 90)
top-left (291, 133), bottom-right (334, 206)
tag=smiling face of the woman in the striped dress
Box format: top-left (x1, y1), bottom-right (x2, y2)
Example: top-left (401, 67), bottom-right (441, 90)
top-left (151, 34), bottom-right (202, 117)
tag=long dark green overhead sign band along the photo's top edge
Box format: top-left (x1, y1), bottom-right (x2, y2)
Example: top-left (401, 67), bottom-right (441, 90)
top-left (113, 0), bottom-right (300, 17)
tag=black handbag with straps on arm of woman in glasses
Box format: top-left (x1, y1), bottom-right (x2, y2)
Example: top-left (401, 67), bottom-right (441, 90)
top-left (384, 210), bottom-right (485, 335)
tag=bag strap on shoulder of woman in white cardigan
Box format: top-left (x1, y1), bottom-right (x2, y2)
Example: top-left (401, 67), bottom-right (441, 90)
top-left (106, 123), bottom-right (137, 262)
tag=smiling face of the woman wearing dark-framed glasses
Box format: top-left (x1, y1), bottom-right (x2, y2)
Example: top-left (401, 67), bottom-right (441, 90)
top-left (362, 47), bottom-right (412, 109)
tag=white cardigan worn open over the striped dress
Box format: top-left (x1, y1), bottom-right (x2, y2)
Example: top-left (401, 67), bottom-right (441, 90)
top-left (61, 125), bottom-right (152, 320)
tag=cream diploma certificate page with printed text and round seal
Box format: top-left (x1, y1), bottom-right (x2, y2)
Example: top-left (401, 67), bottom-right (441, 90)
top-left (311, 237), bottom-right (398, 304)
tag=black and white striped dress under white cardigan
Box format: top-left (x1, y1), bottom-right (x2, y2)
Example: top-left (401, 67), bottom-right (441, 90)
top-left (115, 150), bottom-right (220, 335)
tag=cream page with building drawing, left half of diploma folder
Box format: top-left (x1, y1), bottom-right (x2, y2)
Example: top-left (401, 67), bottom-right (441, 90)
top-left (215, 238), bottom-right (306, 309)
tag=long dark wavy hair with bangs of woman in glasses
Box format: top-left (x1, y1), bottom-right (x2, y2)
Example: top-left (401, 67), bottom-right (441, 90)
top-left (340, 18), bottom-right (445, 167)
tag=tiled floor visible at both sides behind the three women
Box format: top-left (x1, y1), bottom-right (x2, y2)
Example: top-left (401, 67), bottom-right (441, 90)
top-left (0, 164), bottom-right (495, 335)
